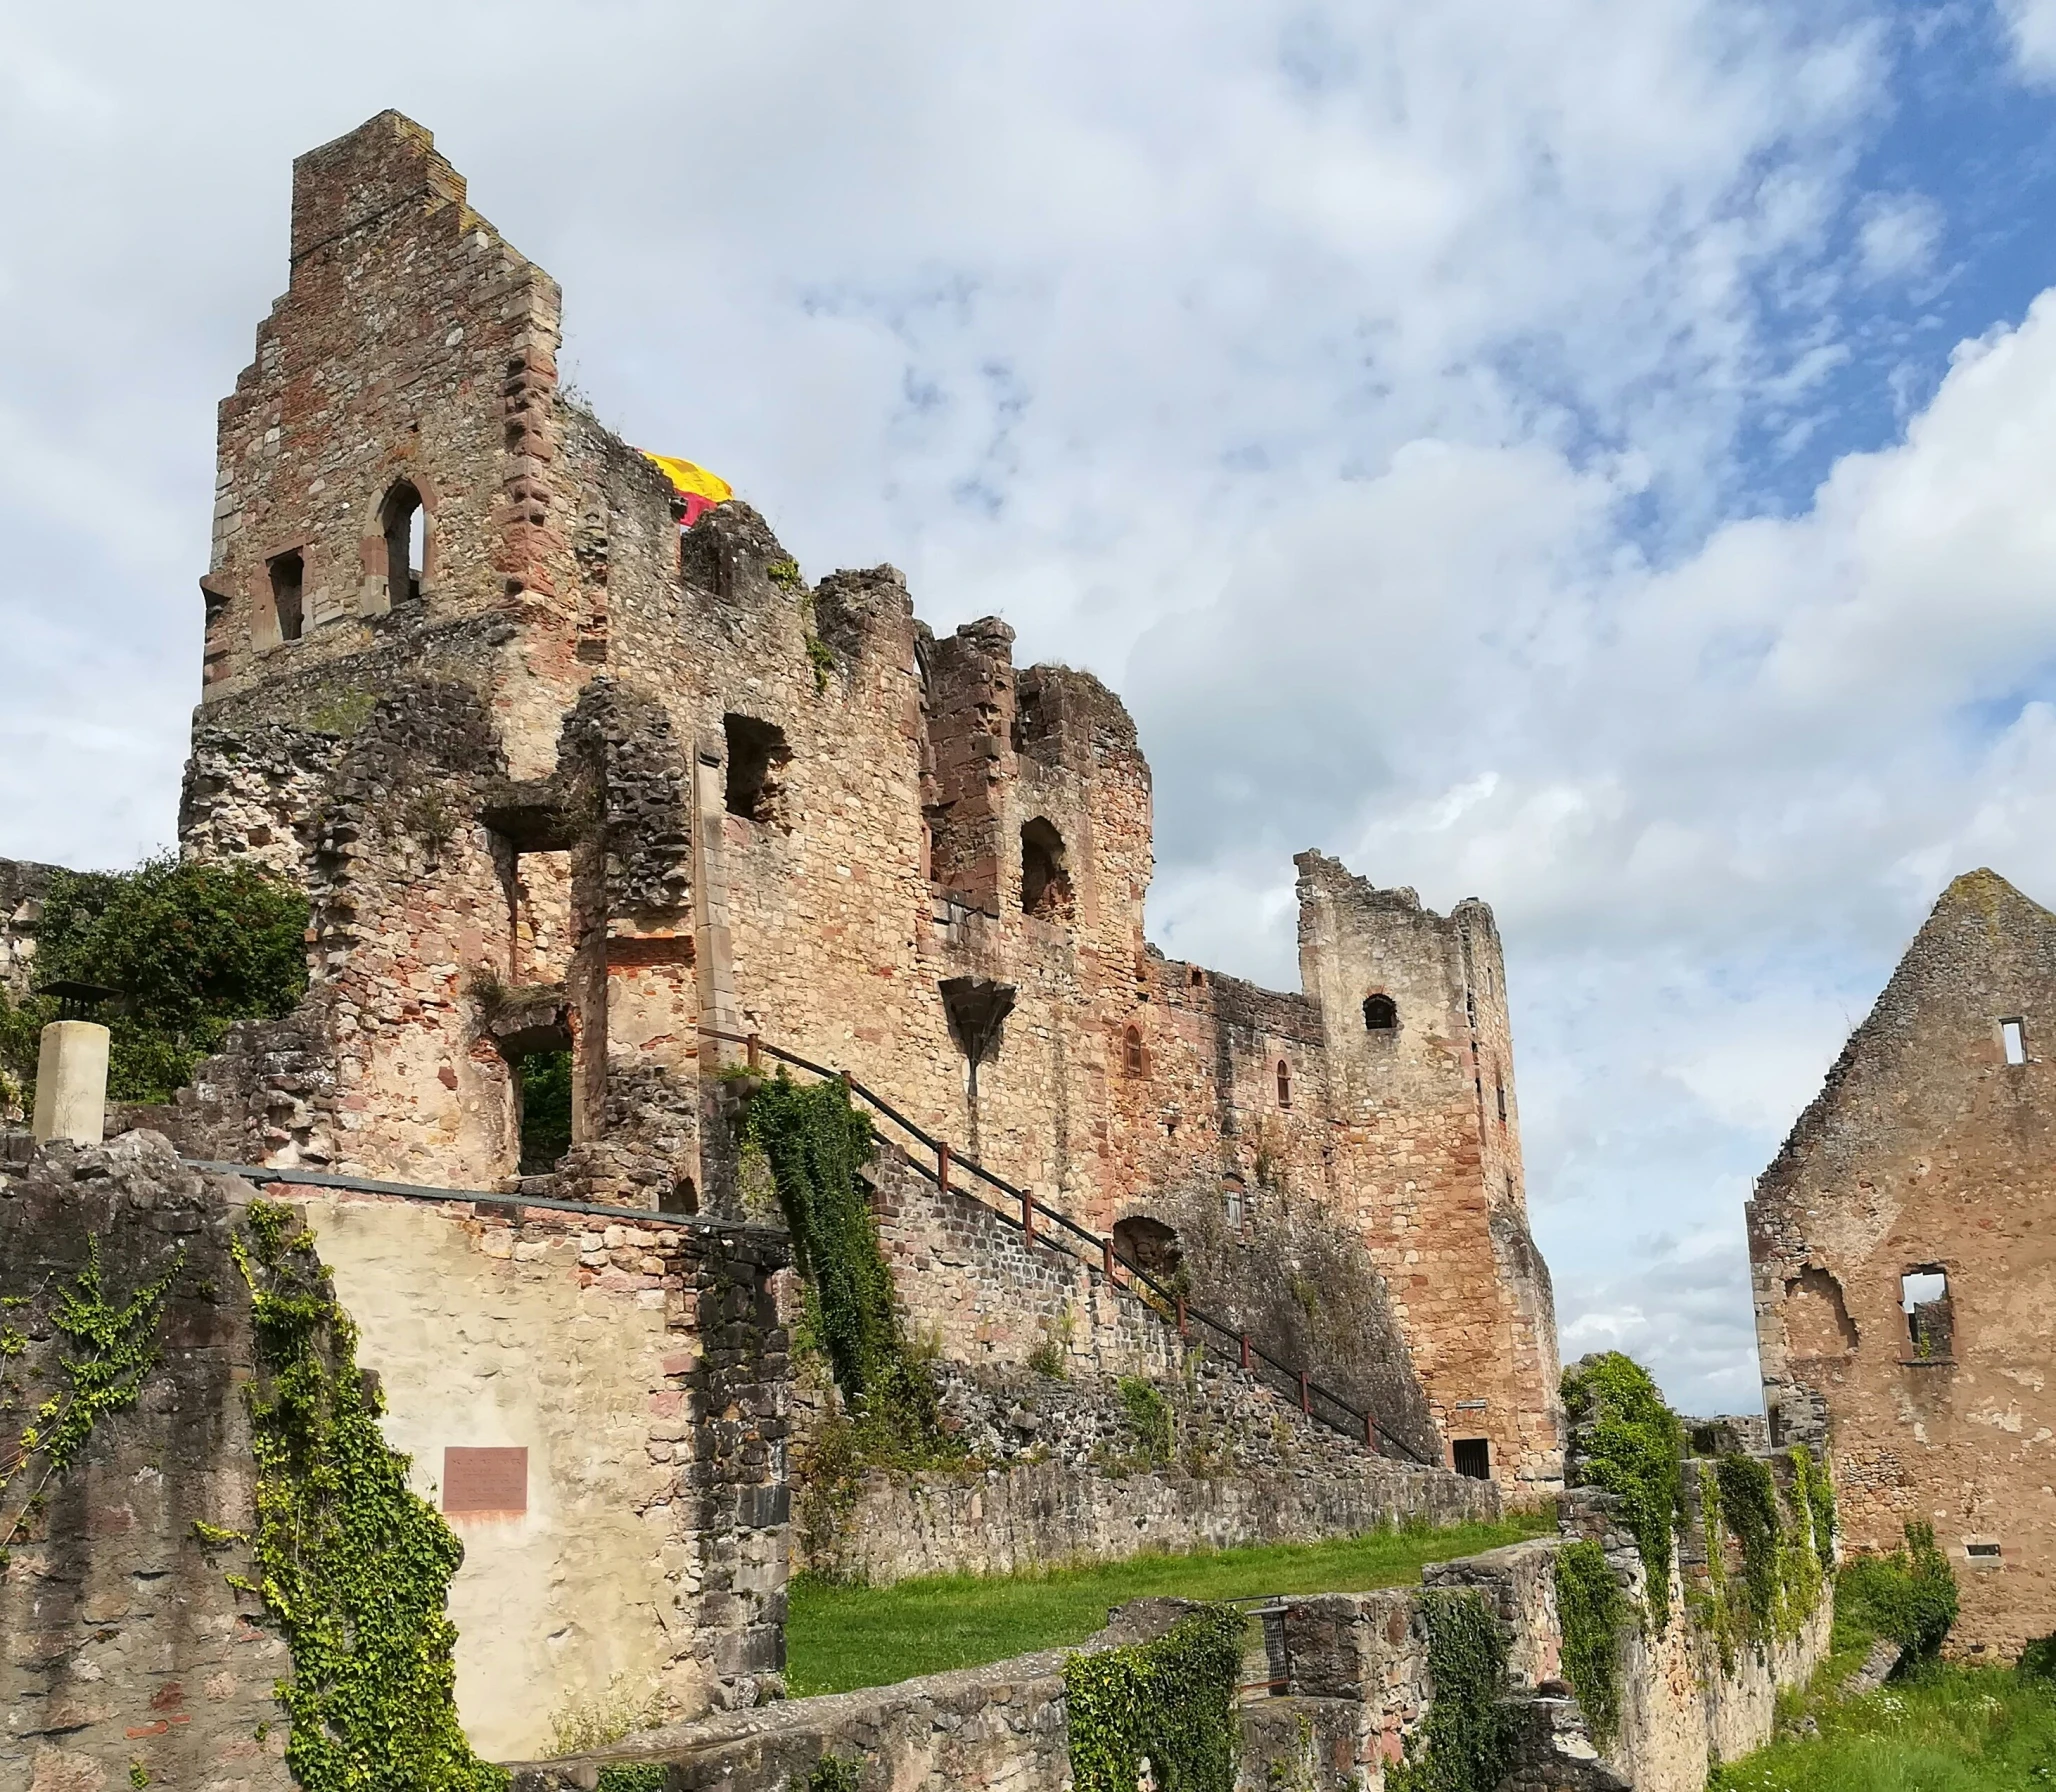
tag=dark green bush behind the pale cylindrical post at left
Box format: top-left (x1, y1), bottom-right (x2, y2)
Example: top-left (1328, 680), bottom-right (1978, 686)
top-left (0, 857), bottom-right (306, 1102)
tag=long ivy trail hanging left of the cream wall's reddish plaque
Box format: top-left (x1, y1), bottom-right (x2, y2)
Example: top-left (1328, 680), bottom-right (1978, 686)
top-left (228, 1202), bottom-right (508, 1792)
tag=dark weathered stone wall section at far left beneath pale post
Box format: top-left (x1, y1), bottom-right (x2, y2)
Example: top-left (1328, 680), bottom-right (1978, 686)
top-left (0, 1132), bottom-right (290, 1792)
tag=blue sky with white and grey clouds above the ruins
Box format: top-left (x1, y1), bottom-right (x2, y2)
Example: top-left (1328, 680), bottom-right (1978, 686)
top-left (0, 0), bottom-right (2056, 1410)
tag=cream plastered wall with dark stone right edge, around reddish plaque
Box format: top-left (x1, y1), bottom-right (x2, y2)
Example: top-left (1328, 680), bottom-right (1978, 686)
top-left (267, 1182), bottom-right (787, 1757)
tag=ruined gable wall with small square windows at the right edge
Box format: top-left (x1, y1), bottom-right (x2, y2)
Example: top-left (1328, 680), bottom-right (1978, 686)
top-left (1750, 871), bottom-right (2056, 1652)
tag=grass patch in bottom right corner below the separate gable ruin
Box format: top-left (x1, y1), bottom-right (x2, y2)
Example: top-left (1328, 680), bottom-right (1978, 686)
top-left (1715, 1667), bottom-right (2056, 1792)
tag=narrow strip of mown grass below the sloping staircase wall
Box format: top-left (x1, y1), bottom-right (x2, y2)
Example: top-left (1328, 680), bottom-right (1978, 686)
top-left (785, 1515), bottom-right (1556, 1697)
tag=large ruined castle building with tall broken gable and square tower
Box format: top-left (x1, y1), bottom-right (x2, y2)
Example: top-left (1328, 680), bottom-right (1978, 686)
top-left (177, 113), bottom-right (1561, 1486)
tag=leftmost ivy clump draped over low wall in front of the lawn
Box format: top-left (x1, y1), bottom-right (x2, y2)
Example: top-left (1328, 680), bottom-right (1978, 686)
top-left (1063, 1605), bottom-right (1246, 1792)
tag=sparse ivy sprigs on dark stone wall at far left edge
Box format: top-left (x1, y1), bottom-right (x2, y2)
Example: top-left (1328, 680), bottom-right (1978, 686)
top-left (0, 1237), bottom-right (185, 1568)
